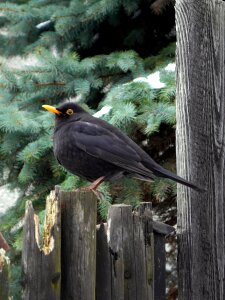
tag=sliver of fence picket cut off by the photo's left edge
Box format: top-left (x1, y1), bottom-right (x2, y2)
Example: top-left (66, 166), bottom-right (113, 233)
top-left (0, 248), bottom-right (9, 300)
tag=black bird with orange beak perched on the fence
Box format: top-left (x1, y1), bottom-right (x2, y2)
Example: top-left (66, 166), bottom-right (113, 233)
top-left (43, 102), bottom-right (201, 191)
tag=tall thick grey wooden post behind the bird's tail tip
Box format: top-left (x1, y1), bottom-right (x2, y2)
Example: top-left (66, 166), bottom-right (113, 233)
top-left (176, 0), bottom-right (225, 300)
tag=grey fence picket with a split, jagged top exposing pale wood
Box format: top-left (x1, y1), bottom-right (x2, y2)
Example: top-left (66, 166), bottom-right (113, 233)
top-left (22, 192), bottom-right (61, 300)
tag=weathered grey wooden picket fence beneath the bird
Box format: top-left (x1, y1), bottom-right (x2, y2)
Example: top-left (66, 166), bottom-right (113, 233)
top-left (0, 187), bottom-right (173, 300)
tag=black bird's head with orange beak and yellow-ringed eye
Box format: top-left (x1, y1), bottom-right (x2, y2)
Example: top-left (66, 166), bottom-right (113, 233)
top-left (42, 102), bottom-right (87, 124)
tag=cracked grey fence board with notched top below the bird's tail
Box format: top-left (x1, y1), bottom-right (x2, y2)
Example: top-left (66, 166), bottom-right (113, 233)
top-left (108, 203), bottom-right (154, 300)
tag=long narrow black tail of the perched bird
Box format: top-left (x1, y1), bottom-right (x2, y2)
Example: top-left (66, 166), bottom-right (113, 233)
top-left (152, 165), bottom-right (205, 192)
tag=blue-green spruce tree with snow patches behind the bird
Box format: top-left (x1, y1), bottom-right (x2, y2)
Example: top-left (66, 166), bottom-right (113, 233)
top-left (0, 0), bottom-right (176, 299)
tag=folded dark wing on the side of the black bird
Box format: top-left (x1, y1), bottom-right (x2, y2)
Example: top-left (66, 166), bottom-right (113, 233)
top-left (70, 121), bottom-right (153, 178)
